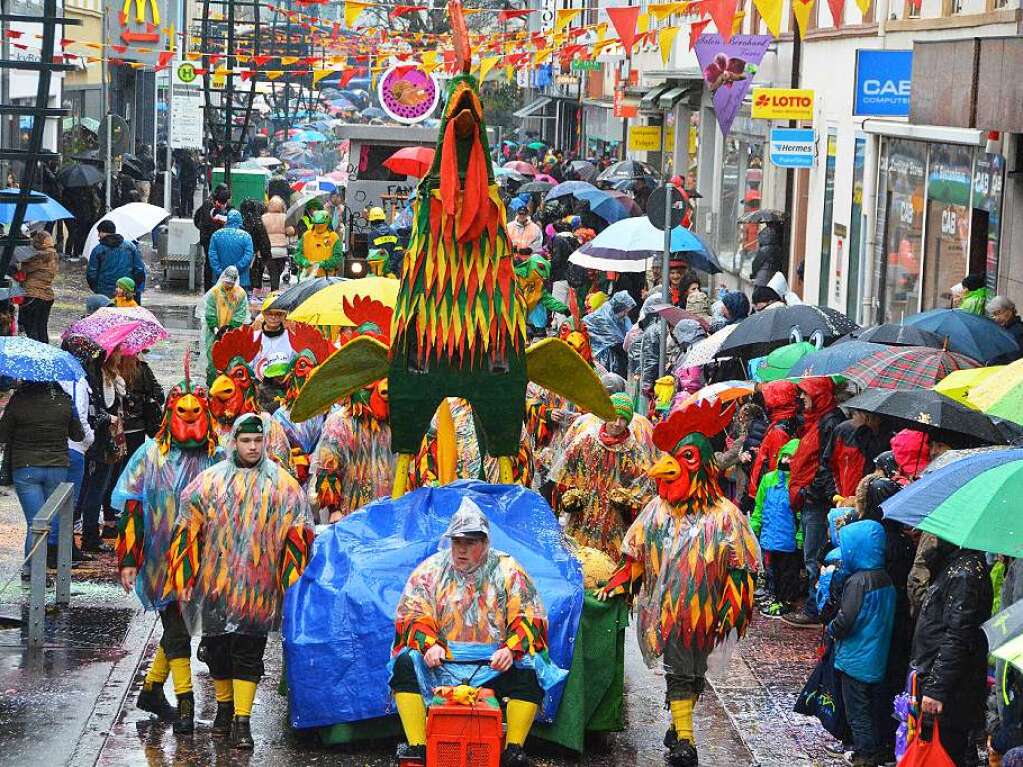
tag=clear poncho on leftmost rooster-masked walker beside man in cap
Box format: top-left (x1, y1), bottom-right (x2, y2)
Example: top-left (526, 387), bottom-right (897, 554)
top-left (110, 438), bottom-right (223, 610)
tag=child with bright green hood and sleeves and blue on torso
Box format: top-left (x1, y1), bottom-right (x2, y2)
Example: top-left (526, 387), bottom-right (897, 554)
top-left (750, 440), bottom-right (803, 618)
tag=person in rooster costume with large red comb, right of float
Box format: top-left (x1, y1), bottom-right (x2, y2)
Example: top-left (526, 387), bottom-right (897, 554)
top-left (601, 403), bottom-right (760, 767)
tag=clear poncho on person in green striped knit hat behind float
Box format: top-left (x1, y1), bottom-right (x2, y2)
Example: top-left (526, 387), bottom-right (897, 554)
top-left (550, 414), bottom-right (660, 560)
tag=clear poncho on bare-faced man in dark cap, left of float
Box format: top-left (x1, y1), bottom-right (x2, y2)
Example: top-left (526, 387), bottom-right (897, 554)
top-left (170, 414), bottom-right (313, 635)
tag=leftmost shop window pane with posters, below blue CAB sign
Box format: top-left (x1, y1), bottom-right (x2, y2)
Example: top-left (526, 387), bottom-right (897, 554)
top-left (878, 139), bottom-right (927, 322)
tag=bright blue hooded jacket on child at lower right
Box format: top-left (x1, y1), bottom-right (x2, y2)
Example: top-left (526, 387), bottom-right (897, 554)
top-left (828, 520), bottom-right (895, 684)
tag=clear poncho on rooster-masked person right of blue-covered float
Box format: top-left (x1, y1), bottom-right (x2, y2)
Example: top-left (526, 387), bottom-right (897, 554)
top-left (622, 496), bottom-right (760, 671)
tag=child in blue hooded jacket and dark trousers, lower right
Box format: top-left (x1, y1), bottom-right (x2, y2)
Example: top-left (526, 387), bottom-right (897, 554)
top-left (828, 520), bottom-right (895, 767)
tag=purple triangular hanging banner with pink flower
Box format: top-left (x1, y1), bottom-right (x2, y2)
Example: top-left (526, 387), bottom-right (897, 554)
top-left (695, 35), bottom-right (772, 136)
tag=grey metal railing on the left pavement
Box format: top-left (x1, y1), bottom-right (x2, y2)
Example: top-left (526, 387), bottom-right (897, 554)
top-left (27, 482), bottom-right (75, 649)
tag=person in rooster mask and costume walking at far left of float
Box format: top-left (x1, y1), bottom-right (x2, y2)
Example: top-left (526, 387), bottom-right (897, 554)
top-left (110, 353), bottom-right (219, 734)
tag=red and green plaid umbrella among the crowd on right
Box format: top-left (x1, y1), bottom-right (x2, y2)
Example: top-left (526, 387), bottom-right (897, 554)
top-left (843, 347), bottom-right (980, 389)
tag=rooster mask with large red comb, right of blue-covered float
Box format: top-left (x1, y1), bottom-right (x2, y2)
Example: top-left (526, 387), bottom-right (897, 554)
top-left (649, 402), bottom-right (732, 511)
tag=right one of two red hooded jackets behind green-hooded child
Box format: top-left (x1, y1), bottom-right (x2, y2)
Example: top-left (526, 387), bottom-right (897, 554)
top-left (789, 376), bottom-right (843, 510)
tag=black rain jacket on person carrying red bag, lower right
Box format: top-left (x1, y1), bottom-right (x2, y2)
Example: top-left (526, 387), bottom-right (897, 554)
top-left (910, 543), bottom-right (994, 729)
